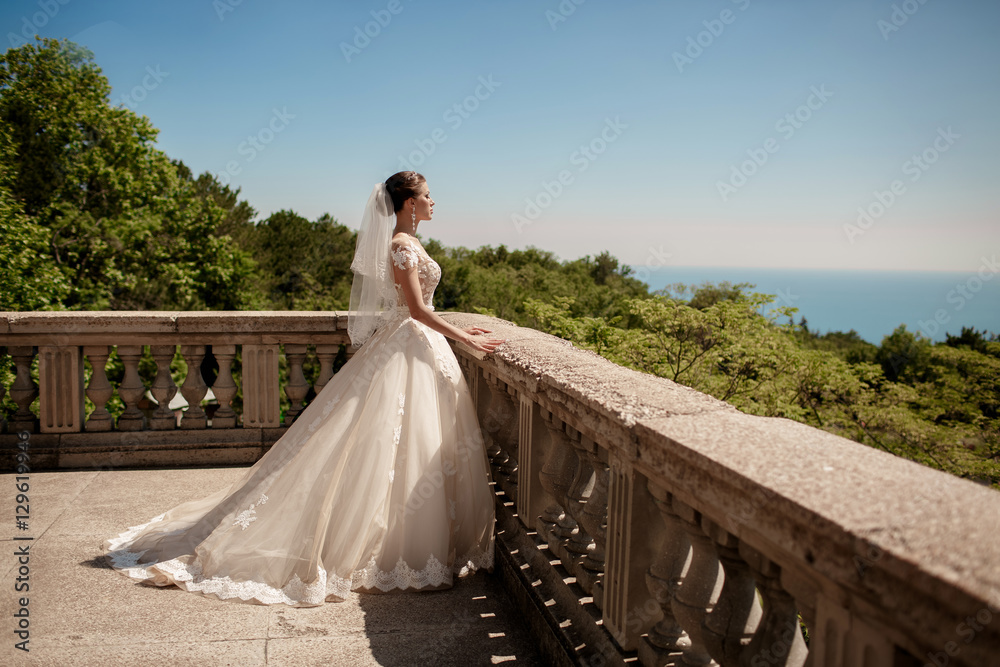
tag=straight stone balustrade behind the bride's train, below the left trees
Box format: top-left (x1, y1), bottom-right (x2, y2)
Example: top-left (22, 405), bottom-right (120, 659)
top-left (0, 311), bottom-right (350, 470)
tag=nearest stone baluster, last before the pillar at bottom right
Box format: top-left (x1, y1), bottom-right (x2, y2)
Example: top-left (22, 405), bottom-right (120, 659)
top-left (739, 541), bottom-right (809, 667)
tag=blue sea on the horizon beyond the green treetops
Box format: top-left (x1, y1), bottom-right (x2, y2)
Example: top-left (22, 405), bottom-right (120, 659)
top-left (633, 266), bottom-right (1000, 345)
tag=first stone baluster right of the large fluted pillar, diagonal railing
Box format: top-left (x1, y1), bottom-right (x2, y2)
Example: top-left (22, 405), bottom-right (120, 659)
top-left (639, 481), bottom-right (691, 667)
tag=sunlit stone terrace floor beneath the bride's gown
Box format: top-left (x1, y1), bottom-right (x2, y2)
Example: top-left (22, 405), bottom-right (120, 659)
top-left (0, 468), bottom-right (543, 667)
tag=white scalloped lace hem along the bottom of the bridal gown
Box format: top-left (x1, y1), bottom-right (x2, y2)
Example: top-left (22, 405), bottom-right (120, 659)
top-left (107, 514), bottom-right (493, 606)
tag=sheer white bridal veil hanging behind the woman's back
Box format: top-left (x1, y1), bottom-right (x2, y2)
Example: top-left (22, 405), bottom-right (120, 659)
top-left (347, 183), bottom-right (396, 347)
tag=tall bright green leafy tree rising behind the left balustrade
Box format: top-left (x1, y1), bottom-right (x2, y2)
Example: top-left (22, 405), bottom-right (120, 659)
top-left (0, 39), bottom-right (253, 310)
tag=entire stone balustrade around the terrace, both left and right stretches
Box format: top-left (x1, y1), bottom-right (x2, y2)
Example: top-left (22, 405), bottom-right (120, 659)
top-left (0, 312), bottom-right (1000, 667)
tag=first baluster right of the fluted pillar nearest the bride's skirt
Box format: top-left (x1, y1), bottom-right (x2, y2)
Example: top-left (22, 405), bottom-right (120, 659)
top-left (536, 408), bottom-right (577, 548)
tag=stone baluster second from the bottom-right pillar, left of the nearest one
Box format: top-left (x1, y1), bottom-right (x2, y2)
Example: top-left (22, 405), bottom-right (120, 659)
top-left (701, 517), bottom-right (763, 665)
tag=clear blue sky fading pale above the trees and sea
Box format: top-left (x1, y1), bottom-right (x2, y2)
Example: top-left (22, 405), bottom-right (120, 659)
top-left (0, 0), bottom-right (1000, 271)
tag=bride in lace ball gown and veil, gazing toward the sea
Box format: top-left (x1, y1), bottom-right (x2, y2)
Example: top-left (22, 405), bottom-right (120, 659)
top-left (104, 171), bottom-right (503, 607)
